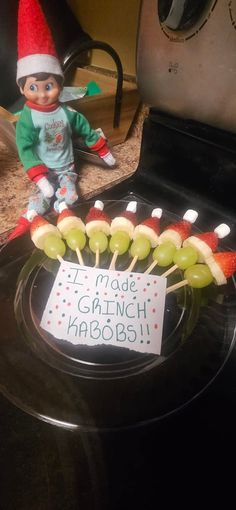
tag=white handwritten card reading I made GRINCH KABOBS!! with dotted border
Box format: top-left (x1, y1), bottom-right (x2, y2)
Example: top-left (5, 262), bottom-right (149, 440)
top-left (40, 261), bottom-right (166, 354)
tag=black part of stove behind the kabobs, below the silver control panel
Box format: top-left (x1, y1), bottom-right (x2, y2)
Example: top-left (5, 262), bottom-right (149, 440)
top-left (101, 109), bottom-right (236, 247)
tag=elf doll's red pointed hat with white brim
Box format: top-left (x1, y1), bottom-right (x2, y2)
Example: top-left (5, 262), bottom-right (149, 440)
top-left (16, 0), bottom-right (63, 82)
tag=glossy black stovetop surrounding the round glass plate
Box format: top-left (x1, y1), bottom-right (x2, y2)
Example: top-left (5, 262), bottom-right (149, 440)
top-left (0, 110), bottom-right (236, 510)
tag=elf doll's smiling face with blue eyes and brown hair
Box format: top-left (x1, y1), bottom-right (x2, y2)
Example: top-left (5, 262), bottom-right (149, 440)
top-left (20, 76), bottom-right (61, 106)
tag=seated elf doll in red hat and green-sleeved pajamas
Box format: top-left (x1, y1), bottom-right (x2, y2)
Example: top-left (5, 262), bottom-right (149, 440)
top-left (8, 0), bottom-right (115, 240)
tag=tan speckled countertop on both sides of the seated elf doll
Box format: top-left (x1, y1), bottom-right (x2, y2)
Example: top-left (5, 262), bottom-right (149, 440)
top-left (0, 106), bottom-right (148, 243)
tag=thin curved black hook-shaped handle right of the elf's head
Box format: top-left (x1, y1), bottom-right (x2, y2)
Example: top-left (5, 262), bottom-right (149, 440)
top-left (63, 40), bottom-right (123, 128)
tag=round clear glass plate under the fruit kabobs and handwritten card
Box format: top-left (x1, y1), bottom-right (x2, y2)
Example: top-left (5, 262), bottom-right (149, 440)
top-left (0, 201), bottom-right (236, 430)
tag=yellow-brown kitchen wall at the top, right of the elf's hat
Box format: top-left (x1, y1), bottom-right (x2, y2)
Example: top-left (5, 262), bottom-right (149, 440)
top-left (68, 0), bottom-right (140, 75)
